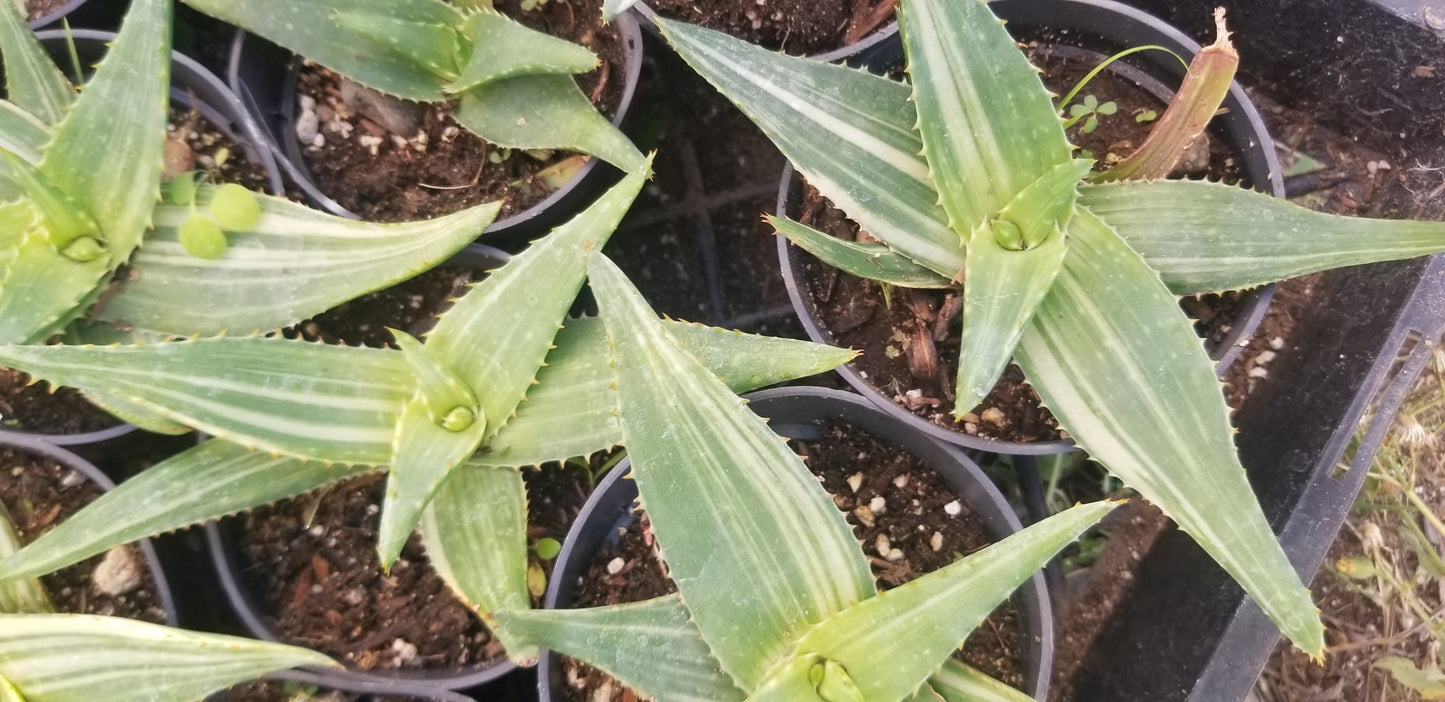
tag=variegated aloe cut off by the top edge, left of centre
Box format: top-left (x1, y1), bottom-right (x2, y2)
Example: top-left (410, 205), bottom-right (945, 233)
top-left (186, 0), bottom-right (643, 178)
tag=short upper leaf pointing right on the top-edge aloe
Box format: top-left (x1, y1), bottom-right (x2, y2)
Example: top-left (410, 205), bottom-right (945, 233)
top-left (445, 10), bottom-right (597, 92)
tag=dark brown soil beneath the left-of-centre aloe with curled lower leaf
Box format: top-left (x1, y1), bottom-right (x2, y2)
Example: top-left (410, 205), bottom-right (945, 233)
top-left (237, 467), bottom-right (590, 670)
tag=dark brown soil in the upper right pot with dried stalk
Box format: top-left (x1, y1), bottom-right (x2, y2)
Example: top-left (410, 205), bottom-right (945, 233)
top-left (798, 42), bottom-right (1238, 442)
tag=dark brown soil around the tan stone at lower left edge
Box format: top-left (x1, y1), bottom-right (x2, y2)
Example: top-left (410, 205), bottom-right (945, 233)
top-left (0, 449), bottom-right (166, 624)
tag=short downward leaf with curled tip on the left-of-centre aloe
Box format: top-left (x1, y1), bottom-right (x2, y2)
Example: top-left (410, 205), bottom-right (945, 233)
top-left (422, 461), bottom-right (538, 664)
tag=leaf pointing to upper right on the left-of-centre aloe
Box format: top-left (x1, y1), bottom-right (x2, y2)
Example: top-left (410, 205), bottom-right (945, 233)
top-left (426, 161), bottom-right (647, 439)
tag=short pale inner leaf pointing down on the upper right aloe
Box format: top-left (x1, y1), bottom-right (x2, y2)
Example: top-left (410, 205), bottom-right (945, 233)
top-left (954, 222), bottom-right (1068, 419)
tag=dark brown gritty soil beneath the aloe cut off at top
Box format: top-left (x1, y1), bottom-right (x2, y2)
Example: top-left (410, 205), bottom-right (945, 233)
top-left (298, 0), bottom-right (626, 221)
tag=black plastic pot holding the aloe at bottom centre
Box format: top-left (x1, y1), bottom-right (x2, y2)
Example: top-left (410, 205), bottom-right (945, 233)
top-left (538, 387), bottom-right (1053, 702)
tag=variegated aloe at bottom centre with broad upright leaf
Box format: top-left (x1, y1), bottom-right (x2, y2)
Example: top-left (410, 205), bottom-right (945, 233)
top-left (496, 256), bottom-right (1113, 702)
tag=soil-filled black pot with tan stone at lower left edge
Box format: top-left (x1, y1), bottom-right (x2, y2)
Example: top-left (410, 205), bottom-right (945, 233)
top-left (0, 435), bottom-right (178, 627)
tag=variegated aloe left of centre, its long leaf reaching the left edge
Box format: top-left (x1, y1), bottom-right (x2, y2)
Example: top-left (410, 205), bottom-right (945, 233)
top-left (0, 172), bottom-right (854, 662)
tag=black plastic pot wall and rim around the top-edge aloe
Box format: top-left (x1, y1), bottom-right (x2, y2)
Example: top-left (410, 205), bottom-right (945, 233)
top-left (227, 7), bottom-right (643, 243)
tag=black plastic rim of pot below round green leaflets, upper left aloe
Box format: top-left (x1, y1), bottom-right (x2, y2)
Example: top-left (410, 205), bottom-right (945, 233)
top-left (0, 30), bottom-right (282, 446)
